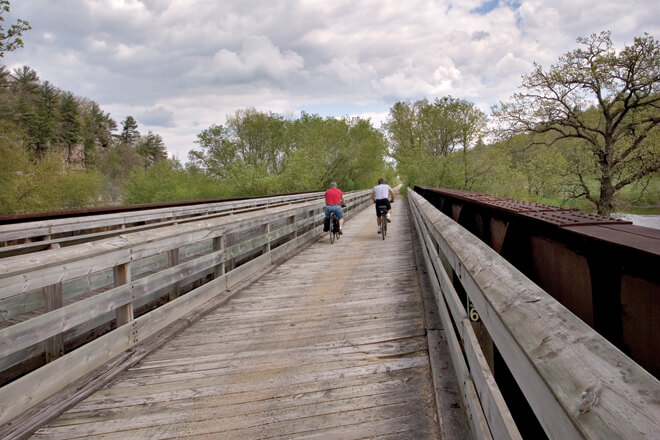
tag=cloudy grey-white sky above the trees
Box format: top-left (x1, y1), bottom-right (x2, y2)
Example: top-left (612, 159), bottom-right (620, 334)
top-left (5, 0), bottom-right (660, 162)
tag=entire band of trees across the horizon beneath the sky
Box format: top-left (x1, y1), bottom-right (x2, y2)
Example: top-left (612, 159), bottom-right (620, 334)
top-left (0, 32), bottom-right (660, 215)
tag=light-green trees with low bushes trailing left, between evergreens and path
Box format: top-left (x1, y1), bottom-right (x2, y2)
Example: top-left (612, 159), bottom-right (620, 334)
top-left (125, 109), bottom-right (395, 203)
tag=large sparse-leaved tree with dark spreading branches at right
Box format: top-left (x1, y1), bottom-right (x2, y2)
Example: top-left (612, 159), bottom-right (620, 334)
top-left (493, 32), bottom-right (660, 215)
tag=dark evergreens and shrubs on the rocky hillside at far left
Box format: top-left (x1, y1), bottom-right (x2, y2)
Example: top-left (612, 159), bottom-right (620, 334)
top-left (0, 66), bottom-right (167, 213)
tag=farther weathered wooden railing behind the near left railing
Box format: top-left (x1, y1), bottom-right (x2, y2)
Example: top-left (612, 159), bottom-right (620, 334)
top-left (0, 192), bottom-right (323, 258)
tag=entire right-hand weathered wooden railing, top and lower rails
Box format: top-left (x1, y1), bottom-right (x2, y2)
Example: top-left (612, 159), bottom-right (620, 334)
top-left (409, 191), bottom-right (660, 440)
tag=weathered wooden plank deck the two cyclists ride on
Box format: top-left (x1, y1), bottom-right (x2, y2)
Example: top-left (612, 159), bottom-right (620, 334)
top-left (33, 202), bottom-right (454, 440)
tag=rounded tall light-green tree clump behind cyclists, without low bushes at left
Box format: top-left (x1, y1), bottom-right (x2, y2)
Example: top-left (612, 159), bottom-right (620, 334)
top-left (189, 109), bottom-right (393, 200)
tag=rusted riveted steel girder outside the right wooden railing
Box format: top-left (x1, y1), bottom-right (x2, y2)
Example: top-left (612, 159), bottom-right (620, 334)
top-left (415, 186), bottom-right (660, 377)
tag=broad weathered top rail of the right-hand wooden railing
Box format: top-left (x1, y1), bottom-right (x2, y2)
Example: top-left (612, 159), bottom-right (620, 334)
top-left (410, 194), bottom-right (660, 439)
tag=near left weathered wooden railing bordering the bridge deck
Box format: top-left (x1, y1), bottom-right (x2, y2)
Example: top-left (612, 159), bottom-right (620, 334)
top-left (0, 191), bottom-right (371, 425)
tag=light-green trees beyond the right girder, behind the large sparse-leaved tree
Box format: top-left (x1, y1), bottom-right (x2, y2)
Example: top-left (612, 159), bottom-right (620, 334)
top-left (386, 97), bottom-right (660, 211)
